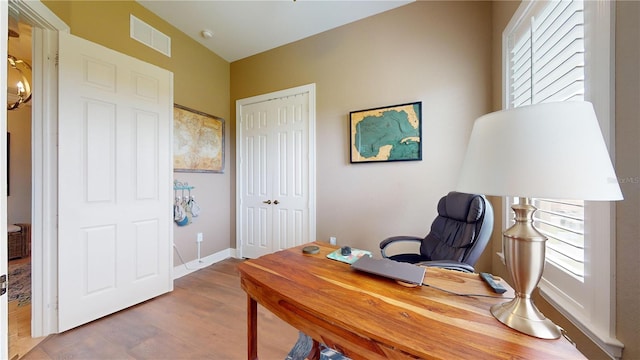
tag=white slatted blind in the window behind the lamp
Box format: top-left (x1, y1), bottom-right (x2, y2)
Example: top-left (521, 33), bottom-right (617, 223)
top-left (508, 0), bottom-right (585, 281)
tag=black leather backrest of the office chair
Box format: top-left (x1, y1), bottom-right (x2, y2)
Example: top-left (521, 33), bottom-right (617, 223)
top-left (420, 191), bottom-right (493, 266)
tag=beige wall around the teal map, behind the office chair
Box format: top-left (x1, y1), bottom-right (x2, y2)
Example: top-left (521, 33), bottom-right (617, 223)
top-left (230, 1), bottom-right (491, 264)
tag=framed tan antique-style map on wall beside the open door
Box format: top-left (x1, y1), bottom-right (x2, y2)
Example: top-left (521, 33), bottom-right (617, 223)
top-left (173, 104), bottom-right (224, 173)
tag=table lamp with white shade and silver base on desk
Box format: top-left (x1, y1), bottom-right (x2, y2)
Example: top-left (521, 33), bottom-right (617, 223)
top-left (457, 101), bottom-right (622, 339)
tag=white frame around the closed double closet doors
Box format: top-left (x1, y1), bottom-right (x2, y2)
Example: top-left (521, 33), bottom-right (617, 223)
top-left (236, 83), bottom-right (316, 258)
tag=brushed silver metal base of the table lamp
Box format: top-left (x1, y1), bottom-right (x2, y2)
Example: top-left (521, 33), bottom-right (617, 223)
top-left (491, 201), bottom-right (561, 339)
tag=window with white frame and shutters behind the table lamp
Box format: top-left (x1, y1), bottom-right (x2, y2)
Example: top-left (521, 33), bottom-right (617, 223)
top-left (503, 0), bottom-right (623, 357)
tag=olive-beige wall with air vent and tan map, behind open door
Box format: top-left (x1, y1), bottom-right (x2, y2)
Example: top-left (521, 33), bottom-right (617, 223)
top-left (44, 1), bottom-right (232, 264)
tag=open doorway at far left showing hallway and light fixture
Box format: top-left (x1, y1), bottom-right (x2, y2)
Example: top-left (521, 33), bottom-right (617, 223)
top-left (6, 12), bottom-right (41, 359)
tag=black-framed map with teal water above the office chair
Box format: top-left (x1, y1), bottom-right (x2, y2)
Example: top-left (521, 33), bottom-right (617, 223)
top-left (349, 102), bottom-right (422, 163)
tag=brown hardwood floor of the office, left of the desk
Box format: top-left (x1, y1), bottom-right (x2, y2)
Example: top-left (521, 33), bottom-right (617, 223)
top-left (22, 259), bottom-right (298, 360)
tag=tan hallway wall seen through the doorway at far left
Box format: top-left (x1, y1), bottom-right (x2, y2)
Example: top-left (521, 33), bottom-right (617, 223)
top-left (7, 105), bottom-right (31, 224)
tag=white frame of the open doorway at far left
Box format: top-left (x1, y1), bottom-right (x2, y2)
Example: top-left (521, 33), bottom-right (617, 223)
top-left (5, 0), bottom-right (70, 337)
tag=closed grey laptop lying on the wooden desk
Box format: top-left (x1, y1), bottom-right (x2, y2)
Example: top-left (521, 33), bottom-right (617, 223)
top-left (351, 256), bottom-right (427, 285)
